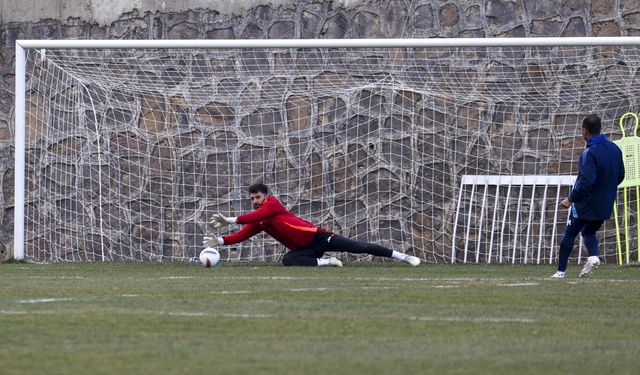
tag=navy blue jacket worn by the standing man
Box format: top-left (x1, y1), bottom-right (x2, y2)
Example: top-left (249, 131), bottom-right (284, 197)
top-left (569, 134), bottom-right (624, 220)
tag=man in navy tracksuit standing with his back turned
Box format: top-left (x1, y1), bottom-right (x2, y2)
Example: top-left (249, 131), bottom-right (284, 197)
top-left (551, 115), bottom-right (624, 279)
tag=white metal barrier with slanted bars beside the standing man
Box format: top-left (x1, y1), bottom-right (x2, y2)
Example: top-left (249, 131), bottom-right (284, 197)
top-left (451, 175), bottom-right (582, 264)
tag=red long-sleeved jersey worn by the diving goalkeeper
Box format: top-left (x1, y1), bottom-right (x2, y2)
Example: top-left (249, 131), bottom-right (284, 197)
top-left (222, 195), bottom-right (326, 250)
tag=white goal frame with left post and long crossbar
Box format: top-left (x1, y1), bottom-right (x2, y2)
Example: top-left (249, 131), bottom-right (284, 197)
top-left (13, 36), bottom-right (640, 260)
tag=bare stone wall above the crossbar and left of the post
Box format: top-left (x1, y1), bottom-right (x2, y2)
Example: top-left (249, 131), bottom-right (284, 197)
top-left (0, 0), bottom-right (640, 258)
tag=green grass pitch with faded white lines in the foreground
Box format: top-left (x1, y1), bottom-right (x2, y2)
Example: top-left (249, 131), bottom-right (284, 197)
top-left (0, 263), bottom-right (640, 375)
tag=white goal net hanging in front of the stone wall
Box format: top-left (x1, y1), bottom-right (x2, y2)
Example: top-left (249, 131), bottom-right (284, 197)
top-left (12, 38), bottom-right (640, 263)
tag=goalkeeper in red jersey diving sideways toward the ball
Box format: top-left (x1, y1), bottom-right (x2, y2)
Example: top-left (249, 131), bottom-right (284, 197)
top-left (203, 184), bottom-right (420, 267)
